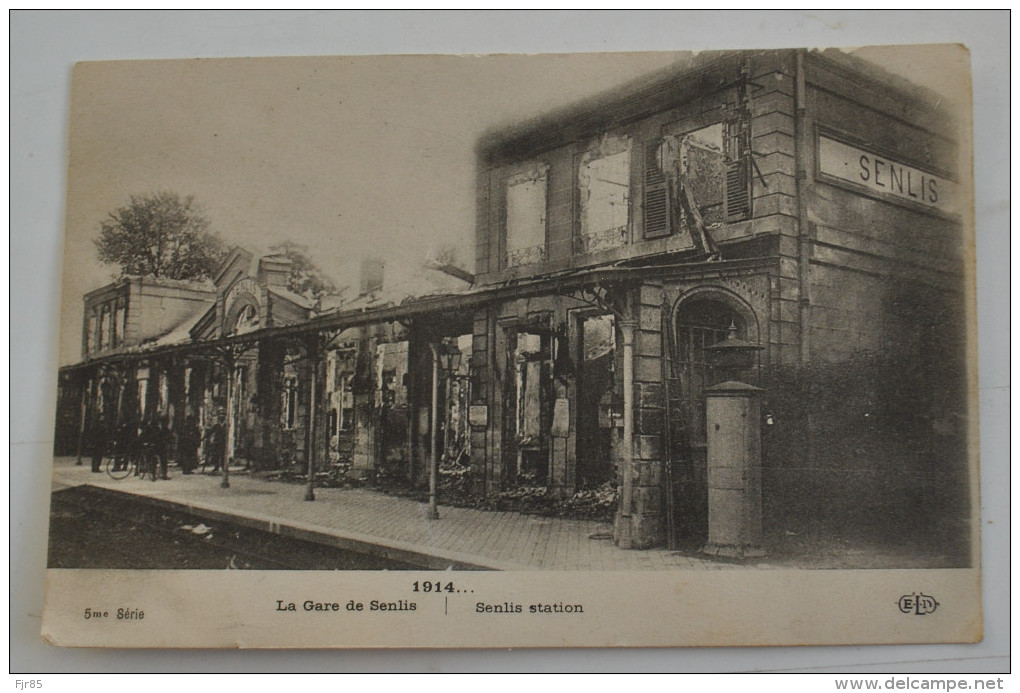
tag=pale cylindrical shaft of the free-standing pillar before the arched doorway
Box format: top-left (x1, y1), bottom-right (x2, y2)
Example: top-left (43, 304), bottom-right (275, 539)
top-left (704, 381), bottom-right (765, 558)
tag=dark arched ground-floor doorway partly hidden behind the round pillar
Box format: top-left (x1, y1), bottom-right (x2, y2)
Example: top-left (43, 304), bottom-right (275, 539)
top-left (666, 288), bottom-right (759, 547)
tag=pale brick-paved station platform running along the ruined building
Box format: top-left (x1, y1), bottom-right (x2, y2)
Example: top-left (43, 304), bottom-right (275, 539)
top-left (53, 457), bottom-right (767, 571)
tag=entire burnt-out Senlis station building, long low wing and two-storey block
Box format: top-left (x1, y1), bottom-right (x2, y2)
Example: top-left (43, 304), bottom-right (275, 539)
top-left (57, 50), bottom-right (970, 555)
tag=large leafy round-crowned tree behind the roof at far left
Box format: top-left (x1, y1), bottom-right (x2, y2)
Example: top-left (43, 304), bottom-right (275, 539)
top-left (95, 192), bottom-right (226, 280)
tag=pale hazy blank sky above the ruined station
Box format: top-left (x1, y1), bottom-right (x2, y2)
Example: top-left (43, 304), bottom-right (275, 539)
top-left (60, 49), bottom-right (966, 364)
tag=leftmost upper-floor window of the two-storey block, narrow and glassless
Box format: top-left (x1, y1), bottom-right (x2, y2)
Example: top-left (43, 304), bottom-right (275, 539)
top-left (506, 166), bottom-right (548, 267)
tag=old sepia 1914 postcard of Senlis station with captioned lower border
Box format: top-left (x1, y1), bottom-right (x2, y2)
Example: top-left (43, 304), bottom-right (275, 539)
top-left (43, 45), bottom-right (982, 648)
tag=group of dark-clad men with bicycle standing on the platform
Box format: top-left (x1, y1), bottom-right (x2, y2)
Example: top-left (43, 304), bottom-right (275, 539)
top-left (84, 412), bottom-right (226, 479)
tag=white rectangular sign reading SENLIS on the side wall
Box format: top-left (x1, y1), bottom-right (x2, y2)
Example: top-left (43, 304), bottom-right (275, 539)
top-left (818, 137), bottom-right (956, 211)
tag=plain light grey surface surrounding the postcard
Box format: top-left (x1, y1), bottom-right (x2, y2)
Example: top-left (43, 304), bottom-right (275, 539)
top-left (9, 11), bottom-right (1010, 673)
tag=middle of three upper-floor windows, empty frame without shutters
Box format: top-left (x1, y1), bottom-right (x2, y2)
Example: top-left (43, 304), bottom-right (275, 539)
top-left (577, 140), bottom-right (630, 253)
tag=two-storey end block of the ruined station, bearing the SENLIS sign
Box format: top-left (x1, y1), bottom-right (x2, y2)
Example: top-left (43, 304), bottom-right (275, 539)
top-left (471, 50), bottom-right (966, 547)
